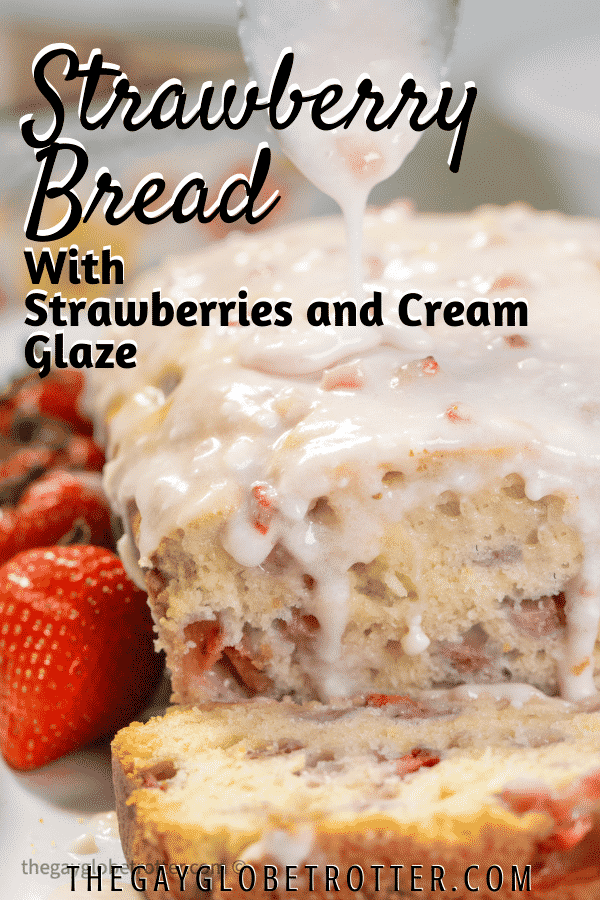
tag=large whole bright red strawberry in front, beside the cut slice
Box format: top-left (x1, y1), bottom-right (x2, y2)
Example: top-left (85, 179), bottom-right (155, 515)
top-left (0, 546), bottom-right (162, 770)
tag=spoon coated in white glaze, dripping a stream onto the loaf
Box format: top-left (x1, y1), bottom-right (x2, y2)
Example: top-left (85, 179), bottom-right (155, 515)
top-left (239, 0), bottom-right (455, 301)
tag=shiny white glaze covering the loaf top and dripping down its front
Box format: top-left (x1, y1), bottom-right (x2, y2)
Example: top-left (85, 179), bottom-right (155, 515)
top-left (91, 206), bottom-right (600, 699)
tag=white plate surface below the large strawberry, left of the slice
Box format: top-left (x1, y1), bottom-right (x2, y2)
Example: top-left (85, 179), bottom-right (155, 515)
top-left (0, 678), bottom-right (170, 900)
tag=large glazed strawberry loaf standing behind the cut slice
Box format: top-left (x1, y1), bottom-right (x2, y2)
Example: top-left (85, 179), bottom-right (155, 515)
top-left (93, 205), bottom-right (600, 702)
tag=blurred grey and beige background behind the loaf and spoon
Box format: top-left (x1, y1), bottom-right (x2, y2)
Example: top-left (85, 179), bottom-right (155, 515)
top-left (0, 0), bottom-right (600, 304)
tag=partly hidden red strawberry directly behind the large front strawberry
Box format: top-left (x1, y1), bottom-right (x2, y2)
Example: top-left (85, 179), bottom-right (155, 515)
top-left (0, 469), bottom-right (113, 564)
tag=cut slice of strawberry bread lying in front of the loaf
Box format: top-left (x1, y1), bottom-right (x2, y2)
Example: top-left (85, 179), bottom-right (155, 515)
top-left (113, 695), bottom-right (600, 900)
